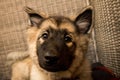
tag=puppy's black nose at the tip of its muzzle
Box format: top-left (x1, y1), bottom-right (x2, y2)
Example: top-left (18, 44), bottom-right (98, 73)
top-left (44, 53), bottom-right (58, 65)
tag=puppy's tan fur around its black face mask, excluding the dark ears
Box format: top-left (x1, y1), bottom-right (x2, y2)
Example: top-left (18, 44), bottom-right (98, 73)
top-left (10, 5), bottom-right (92, 80)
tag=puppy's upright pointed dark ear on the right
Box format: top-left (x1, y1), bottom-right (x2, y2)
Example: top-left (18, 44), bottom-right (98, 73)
top-left (75, 7), bottom-right (93, 34)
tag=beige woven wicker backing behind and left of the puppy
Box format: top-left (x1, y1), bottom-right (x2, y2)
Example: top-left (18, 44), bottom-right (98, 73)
top-left (0, 0), bottom-right (88, 80)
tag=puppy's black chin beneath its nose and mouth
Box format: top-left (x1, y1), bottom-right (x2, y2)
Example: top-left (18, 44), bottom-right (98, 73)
top-left (40, 64), bottom-right (69, 72)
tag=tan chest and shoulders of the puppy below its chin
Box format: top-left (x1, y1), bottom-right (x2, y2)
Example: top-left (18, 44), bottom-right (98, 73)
top-left (11, 58), bottom-right (92, 80)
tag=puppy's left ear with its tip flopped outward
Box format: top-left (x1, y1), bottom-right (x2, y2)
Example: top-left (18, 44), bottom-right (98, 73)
top-left (24, 7), bottom-right (44, 27)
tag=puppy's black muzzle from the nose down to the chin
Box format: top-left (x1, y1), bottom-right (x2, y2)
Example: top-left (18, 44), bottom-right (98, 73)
top-left (39, 52), bottom-right (72, 72)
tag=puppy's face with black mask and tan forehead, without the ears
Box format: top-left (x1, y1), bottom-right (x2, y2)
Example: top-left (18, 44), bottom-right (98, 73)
top-left (37, 17), bottom-right (77, 71)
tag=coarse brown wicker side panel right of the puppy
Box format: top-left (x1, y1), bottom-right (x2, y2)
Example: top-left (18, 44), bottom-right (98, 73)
top-left (91, 0), bottom-right (120, 77)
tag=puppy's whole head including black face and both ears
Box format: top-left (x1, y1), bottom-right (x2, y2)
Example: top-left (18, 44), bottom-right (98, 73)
top-left (26, 8), bottom-right (92, 72)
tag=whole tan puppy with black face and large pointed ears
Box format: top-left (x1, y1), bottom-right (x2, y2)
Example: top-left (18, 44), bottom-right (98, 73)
top-left (8, 6), bottom-right (93, 80)
